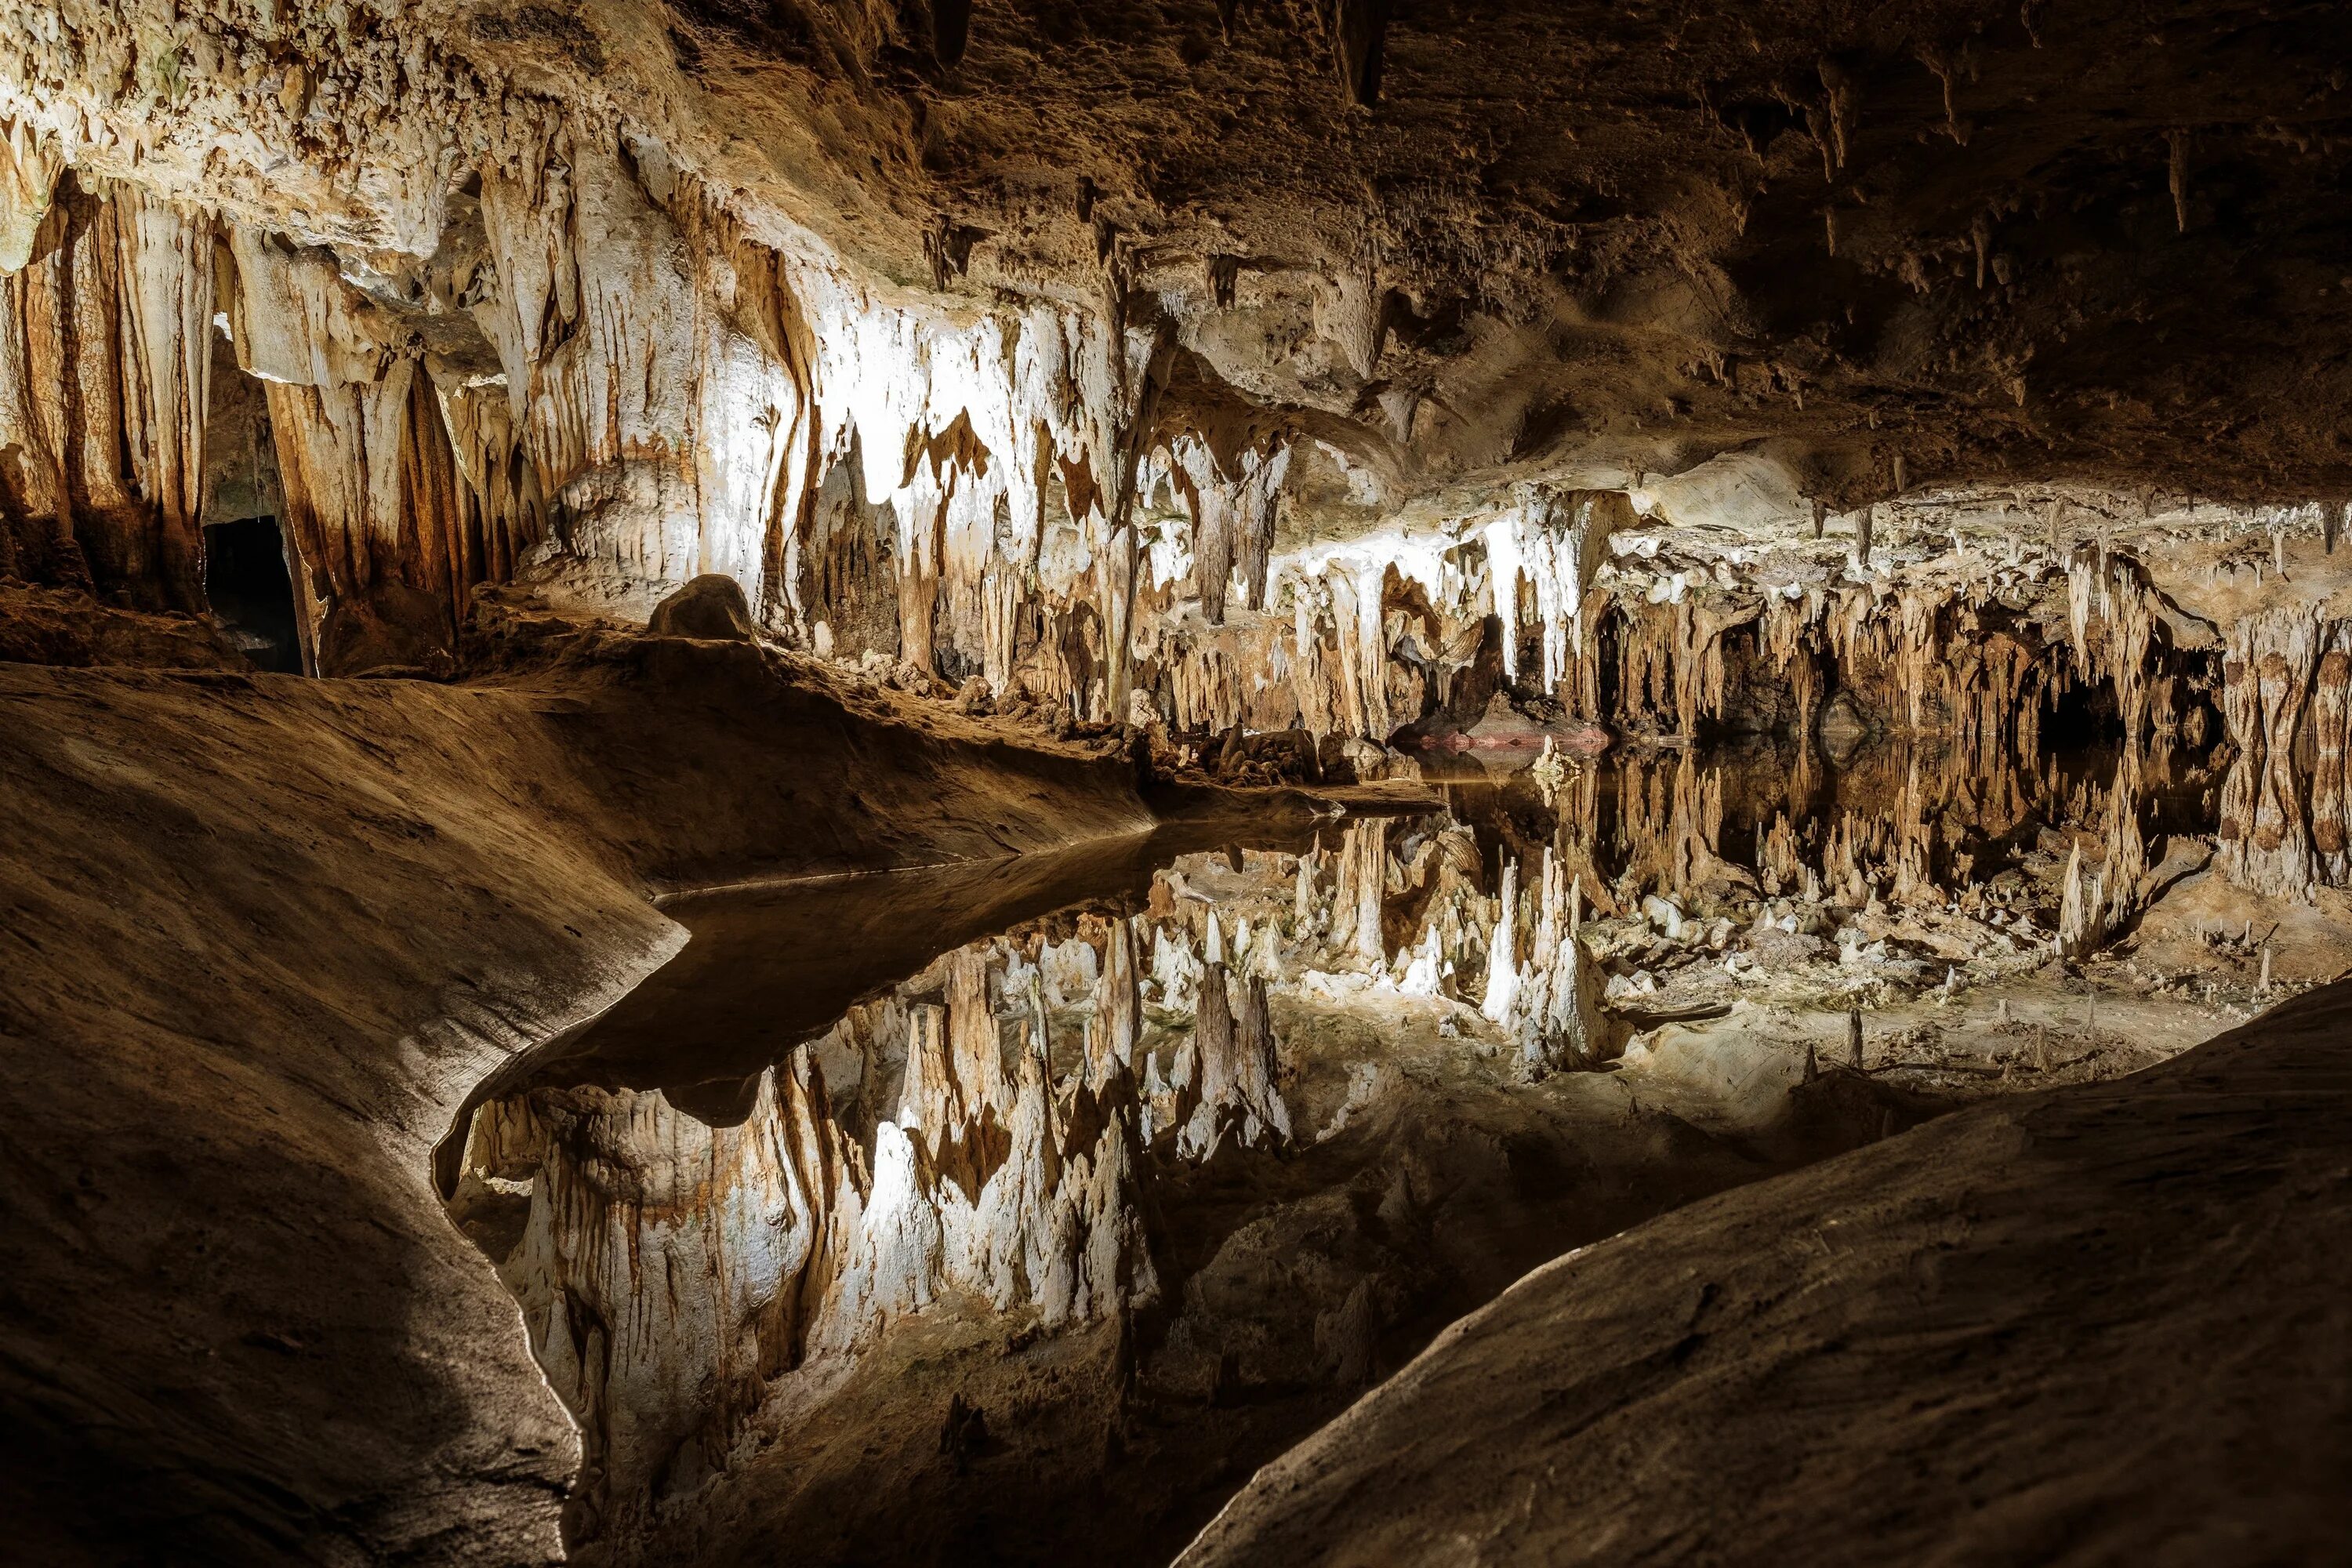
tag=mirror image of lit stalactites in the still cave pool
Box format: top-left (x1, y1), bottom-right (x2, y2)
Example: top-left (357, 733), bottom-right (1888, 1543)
top-left (442, 743), bottom-right (2218, 1542)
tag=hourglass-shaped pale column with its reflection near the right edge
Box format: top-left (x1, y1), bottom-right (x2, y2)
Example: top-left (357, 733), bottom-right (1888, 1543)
top-left (2218, 609), bottom-right (2319, 898)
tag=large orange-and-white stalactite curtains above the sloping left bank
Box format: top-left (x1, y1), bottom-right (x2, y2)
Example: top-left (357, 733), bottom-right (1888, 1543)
top-left (0, 94), bottom-right (1176, 681)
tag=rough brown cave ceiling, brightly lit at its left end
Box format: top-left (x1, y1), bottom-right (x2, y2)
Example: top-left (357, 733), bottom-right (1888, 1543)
top-left (18, 0), bottom-right (2352, 543)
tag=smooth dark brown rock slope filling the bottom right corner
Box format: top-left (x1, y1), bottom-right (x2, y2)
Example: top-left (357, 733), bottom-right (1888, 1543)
top-left (1178, 987), bottom-right (2347, 1566)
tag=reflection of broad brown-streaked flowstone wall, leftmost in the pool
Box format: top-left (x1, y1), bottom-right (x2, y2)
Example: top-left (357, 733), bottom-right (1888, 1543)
top-left (466, 1051), bottom-right (866, 1519)
